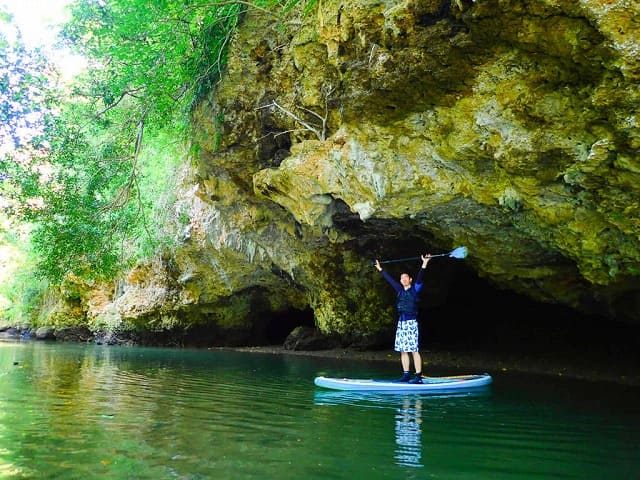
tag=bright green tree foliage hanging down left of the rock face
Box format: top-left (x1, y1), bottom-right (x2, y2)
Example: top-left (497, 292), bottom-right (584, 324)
top-left (0, 0), bottom-right (310, 283)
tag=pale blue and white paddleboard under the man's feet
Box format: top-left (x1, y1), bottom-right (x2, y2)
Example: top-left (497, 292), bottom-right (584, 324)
top-left (314, 373), bottom-right (493, 393)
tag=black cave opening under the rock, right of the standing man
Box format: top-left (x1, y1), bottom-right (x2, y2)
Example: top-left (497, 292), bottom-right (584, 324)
top-left (421, 262), bottom-right (640, 364)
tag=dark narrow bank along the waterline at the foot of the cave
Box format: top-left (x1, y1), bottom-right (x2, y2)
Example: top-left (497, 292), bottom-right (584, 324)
top-left (225, 345), bottom-right (640, 386)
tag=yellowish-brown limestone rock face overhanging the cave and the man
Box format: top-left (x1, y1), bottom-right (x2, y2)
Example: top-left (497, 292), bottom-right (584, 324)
top-left (95, 0), bottom-right (640, 335)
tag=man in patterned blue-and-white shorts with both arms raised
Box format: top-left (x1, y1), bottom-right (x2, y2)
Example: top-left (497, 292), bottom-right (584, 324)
top-left (374, 254), bottom-right (431, 383)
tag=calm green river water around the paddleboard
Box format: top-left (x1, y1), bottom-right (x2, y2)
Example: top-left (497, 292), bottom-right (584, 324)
top-left (0, 341), bottom-right (640, 480)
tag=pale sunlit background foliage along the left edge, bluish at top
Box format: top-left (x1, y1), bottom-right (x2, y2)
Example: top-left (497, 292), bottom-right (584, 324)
top-left (0, 11), bottom-right (55, 325)
